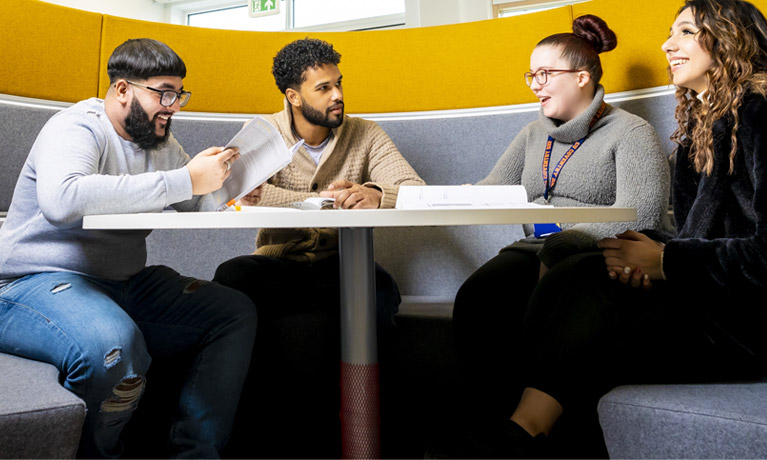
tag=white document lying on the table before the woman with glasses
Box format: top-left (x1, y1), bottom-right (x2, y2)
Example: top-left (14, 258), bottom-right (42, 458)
top-left (396, 185), bottom-right (539, 209)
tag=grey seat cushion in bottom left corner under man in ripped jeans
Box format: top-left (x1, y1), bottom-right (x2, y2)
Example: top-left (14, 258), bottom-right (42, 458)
top-left (0, 353), bottom-right (85, 458)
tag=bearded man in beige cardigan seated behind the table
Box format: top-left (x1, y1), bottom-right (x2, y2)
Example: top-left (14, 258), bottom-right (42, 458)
top-left (214, 39), bottom-right (424, 452)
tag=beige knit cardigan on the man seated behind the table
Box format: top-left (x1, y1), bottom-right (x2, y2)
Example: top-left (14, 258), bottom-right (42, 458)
top-left (255, 101), bottom-right (424, 262)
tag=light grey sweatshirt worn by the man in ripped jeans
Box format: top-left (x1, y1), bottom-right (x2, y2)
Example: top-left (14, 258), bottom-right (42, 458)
top-left (0, 98), bottom-right (215, 286)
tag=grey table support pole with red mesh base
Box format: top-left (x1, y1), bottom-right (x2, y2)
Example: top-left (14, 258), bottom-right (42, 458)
top-left (338, 228), bottom-right (381, 458)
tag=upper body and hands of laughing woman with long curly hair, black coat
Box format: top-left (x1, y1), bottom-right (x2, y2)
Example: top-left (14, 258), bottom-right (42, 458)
top-left (600, 0), bottom-right (767, 356)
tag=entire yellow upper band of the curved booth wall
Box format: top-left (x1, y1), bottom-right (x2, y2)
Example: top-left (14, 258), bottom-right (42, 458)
top-left (0, 0), bottom-right (752, 113)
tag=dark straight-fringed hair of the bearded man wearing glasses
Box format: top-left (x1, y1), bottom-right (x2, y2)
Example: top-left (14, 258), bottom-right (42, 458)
top-left (107, 38), bottom-right (186, 83)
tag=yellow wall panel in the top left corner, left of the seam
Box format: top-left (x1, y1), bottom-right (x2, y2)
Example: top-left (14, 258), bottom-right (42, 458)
top-left (0, 0), bottom-right (101, 102)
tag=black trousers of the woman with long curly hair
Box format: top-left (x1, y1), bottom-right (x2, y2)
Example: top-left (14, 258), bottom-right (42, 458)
top-left (524, 253), bottom-right (766, 407)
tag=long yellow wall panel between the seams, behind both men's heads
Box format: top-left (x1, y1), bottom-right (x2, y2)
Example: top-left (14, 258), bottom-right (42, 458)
top-left (99, 7), bottom-right (572, 113)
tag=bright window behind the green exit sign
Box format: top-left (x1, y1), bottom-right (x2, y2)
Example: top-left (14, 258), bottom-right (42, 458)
top-left (184, 0), bottom-right (405, 31)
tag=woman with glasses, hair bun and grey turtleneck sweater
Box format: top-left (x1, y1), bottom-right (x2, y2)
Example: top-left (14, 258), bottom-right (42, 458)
top-left (453, 15), bottom-right (669, 458)
